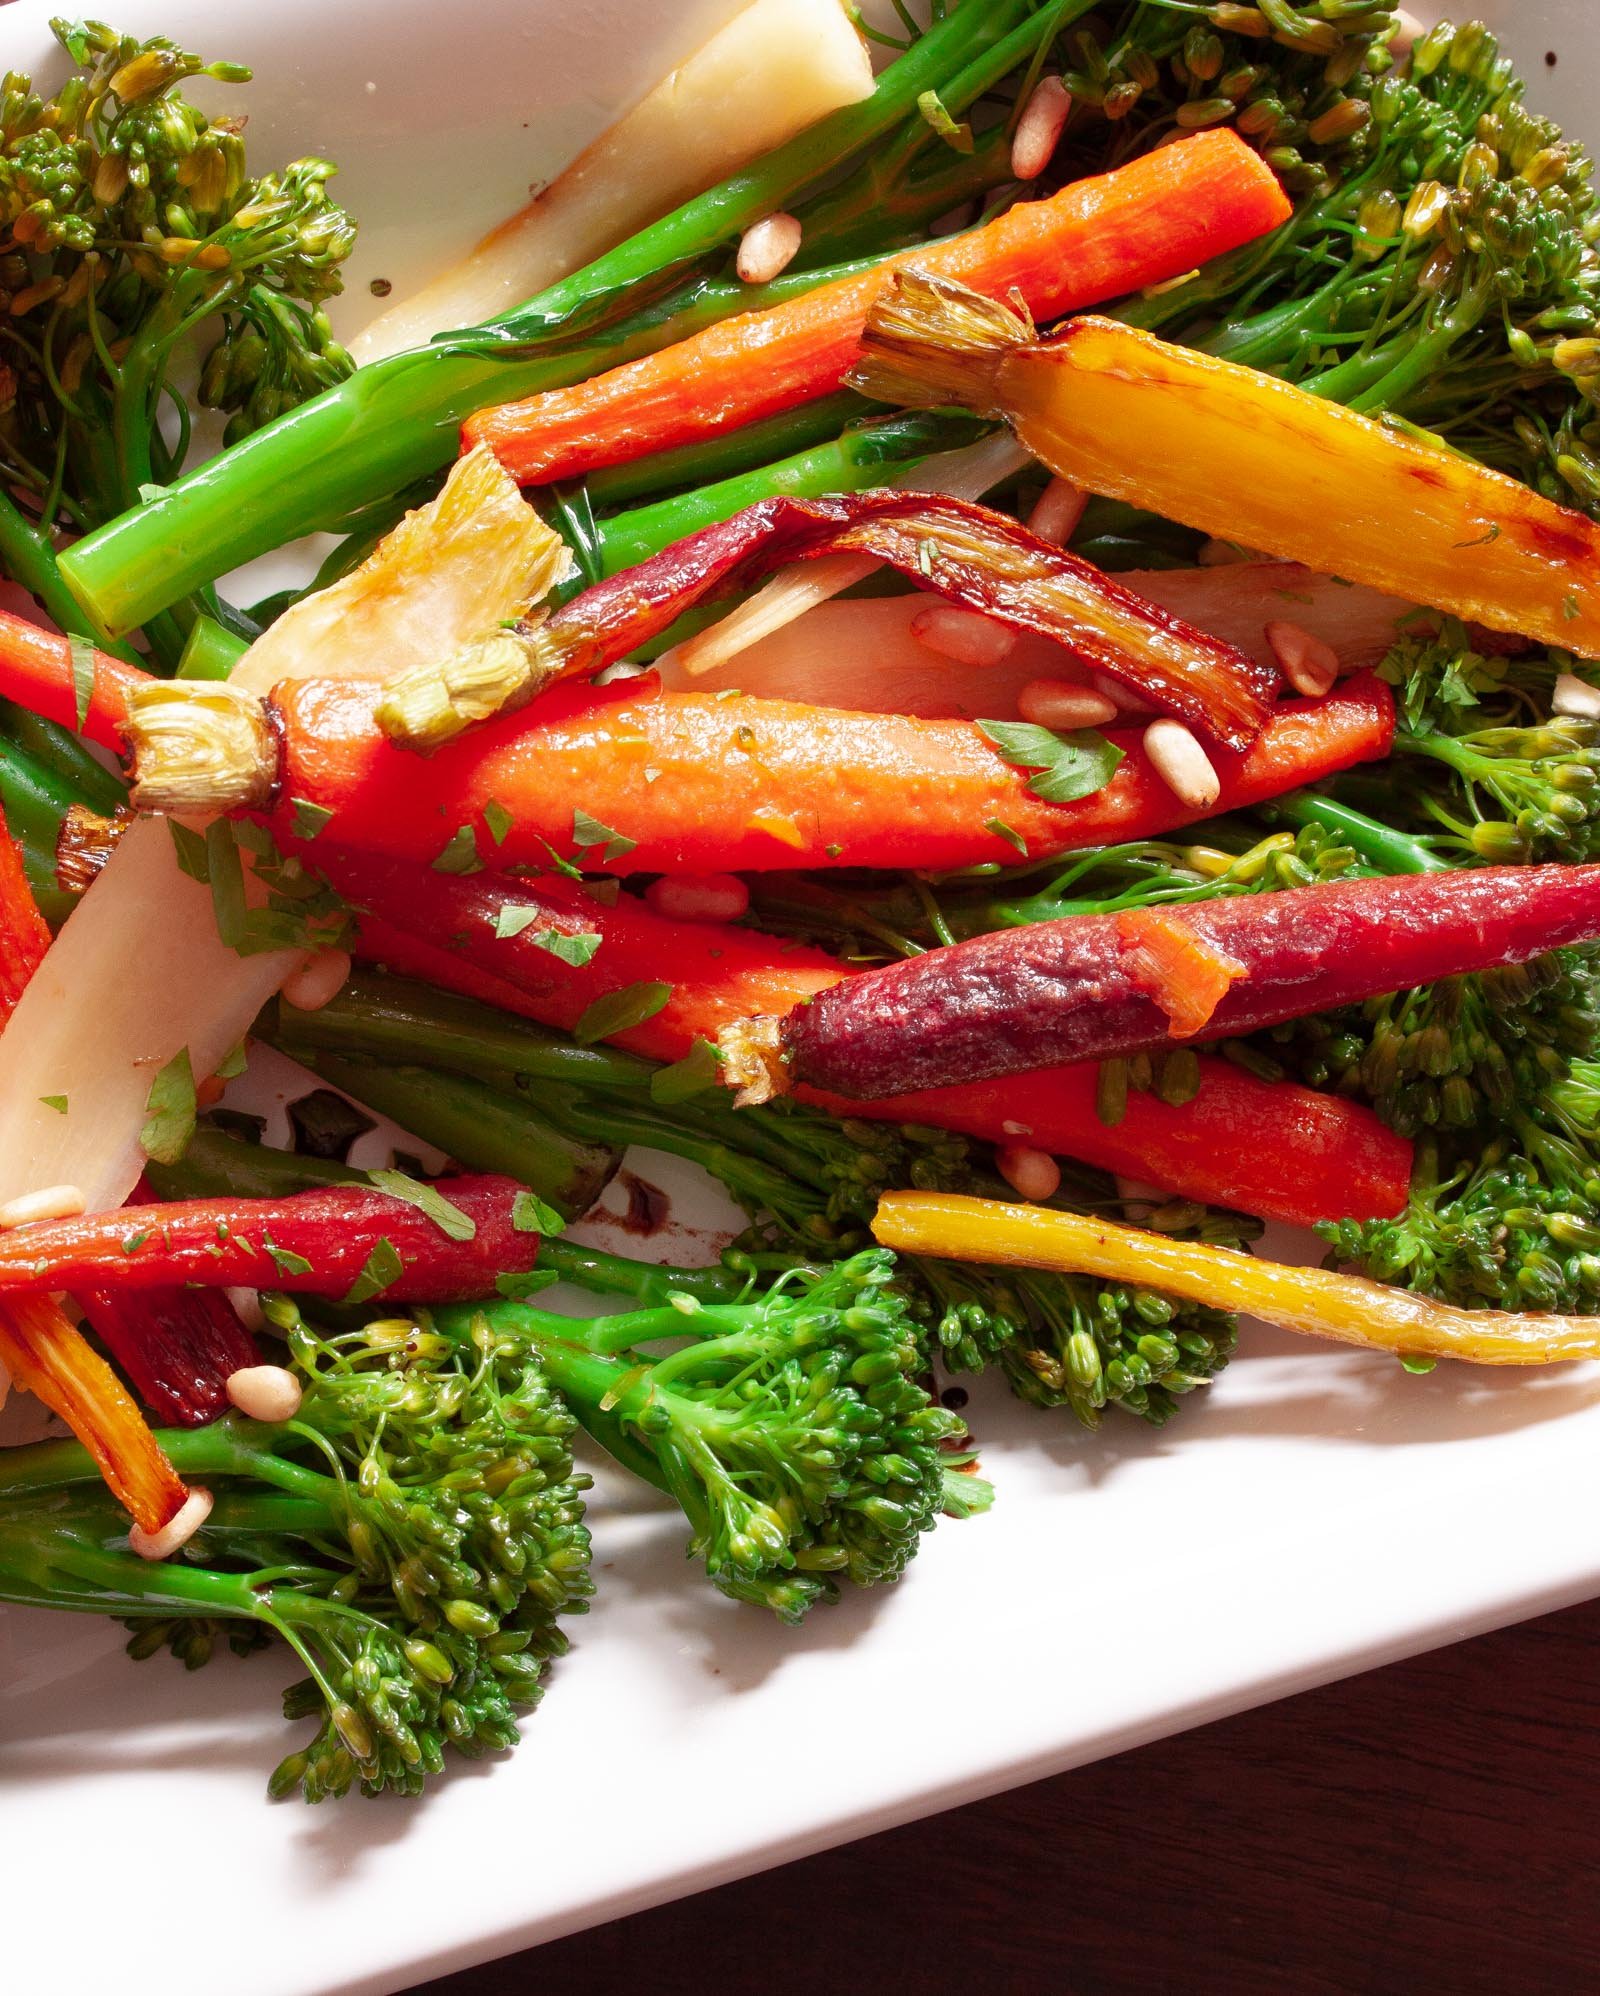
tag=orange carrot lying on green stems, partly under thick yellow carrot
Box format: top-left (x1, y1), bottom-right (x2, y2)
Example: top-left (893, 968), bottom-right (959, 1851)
top-left (463, 132), bottom-right (1291, 485)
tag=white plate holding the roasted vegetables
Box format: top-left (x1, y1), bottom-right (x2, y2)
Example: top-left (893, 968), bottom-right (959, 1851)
top-left (0, 0), bottom-right (1600, 1996)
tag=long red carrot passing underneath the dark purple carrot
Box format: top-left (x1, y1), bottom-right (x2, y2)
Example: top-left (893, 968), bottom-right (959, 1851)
top-left (319, 852), bottom-right (1410, 1224)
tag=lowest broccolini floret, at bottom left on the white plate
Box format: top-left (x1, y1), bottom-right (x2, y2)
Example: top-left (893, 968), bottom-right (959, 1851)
top-left (0, 1305), bottom-right (593, 1802)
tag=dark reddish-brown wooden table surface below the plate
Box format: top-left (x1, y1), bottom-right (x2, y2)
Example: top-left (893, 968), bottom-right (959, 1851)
top-left (417, 1603), bottom-right (1600, 1996)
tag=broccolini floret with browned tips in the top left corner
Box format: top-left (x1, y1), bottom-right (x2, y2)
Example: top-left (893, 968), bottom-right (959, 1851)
top-left (0, 22), bottom-right (355, 665)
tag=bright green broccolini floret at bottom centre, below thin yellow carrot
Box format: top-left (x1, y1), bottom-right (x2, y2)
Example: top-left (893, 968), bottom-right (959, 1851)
top-left (437, 1249), bottom-right (972, 1621)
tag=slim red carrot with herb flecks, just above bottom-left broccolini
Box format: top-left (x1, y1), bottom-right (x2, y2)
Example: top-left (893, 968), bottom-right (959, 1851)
top-left (0, 1176), bottom-right (539, 1303)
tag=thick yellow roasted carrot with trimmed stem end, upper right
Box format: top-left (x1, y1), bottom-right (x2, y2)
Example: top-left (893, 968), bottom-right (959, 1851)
top-left (854, 273), bottom-right (1600, 657)
